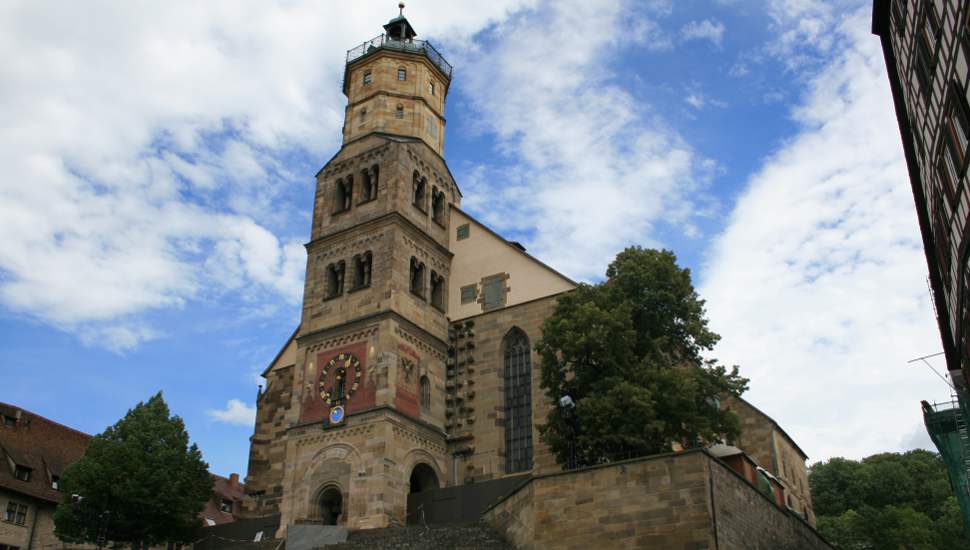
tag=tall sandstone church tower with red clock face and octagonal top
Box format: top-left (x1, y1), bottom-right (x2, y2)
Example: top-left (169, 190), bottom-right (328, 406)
top-left (247, 4), bottom-right (460, 529)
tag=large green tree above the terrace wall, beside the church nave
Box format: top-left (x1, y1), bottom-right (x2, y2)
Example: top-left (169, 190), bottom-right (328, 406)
top-left (536, 247), bottom-right (748, 464)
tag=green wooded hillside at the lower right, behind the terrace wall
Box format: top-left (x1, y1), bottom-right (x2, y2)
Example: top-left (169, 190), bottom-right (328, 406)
top-left (809, 450), bottom-right (970, 550)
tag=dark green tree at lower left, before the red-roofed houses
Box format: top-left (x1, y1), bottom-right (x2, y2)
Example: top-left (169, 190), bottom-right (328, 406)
top-left (54, 392), bottom-right (212, 547)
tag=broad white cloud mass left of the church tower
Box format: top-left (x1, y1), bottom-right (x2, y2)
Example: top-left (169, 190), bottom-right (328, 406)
top-left (0, 0), bottom-right (531, 350)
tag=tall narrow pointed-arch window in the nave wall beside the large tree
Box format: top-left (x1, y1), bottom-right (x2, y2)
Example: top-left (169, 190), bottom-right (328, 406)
top-left (504, 328), bottom-right (532, 473)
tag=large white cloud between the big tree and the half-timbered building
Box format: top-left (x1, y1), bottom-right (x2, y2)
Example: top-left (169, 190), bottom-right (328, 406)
top-left (700, 9), bottom-right (946, 466)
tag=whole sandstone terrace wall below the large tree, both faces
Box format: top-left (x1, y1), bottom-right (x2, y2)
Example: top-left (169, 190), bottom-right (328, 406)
top-left (483, 450), bottom-right (832, 550)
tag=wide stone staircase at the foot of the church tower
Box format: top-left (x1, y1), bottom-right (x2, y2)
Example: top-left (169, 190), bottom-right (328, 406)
top-left (318, 523), bottom-right (515, 550)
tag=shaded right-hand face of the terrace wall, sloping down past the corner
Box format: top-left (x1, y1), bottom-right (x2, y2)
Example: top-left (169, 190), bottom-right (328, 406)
top-left (710, 460), bottom-right (832, 550)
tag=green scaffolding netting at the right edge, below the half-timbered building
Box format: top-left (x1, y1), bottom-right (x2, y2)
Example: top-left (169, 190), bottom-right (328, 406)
top-left (923, 391), bottom-right (970, 537)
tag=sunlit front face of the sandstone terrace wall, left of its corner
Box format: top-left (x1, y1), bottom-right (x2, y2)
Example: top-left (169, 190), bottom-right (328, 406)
top-left (484, 452), bottom-right (715, 550)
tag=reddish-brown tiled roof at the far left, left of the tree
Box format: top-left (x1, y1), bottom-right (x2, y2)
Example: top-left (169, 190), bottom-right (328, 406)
top-left (0, 403), bottom-right (91, 502)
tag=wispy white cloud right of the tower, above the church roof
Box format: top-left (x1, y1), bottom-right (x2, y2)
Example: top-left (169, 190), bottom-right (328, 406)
top-left (458, 0), bottom-right (710, 279)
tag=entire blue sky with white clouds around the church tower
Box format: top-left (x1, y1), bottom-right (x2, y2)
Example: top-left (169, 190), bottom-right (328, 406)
top-left (0, 0), bottom-right (947, 474)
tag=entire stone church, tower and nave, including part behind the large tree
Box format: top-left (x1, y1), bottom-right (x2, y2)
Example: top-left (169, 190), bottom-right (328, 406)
top-left (246, 10), bottom-right (814, 531)
